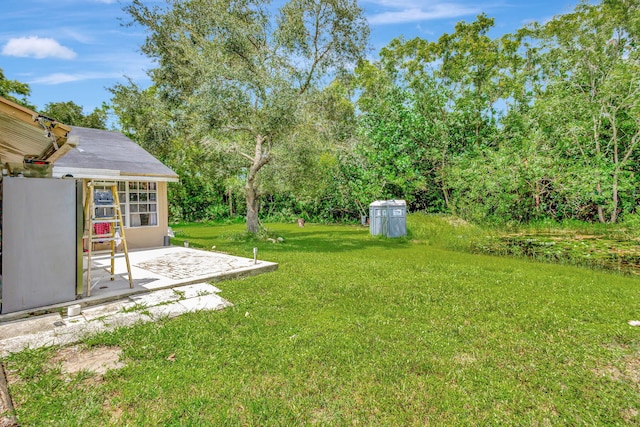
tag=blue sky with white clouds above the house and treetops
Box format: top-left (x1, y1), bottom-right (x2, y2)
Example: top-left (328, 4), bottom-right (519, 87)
top-left (0, 0), bottom-right (578, 113)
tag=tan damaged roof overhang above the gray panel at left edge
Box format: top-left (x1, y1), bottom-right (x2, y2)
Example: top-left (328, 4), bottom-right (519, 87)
top-left (0, 96), bottom-right (76, 163)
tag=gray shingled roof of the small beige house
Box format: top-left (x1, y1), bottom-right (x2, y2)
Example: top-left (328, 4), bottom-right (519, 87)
top-left (56, 126), bottom-right (178, 179)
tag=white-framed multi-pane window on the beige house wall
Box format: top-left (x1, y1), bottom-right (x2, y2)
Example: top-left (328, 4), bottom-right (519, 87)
top-left (118, 181), bottom-right (158, 227)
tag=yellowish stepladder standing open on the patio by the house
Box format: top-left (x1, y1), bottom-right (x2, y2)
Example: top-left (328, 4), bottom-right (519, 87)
top-left (84, 180), bottom-right (133, 296)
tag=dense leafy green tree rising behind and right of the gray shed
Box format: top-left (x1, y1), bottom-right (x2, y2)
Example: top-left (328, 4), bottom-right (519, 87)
top-left (356, 15), bottom-right (519, 211)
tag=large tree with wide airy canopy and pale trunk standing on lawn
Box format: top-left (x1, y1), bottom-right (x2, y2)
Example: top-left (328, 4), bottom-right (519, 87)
top-left (126, 0), bottom-right (368, 233)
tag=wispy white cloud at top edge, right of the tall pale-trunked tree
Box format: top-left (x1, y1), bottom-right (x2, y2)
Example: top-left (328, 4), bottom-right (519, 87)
top-left (368, 0), bottom-right (482, 25)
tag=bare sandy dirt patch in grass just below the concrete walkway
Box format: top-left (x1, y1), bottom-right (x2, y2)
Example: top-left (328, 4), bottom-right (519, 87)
top-left (51, 346), bottom-right (124, 375)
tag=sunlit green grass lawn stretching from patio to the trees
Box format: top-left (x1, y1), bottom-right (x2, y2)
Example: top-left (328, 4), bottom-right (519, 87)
top-left (5, 217), bottom-right (640, 426)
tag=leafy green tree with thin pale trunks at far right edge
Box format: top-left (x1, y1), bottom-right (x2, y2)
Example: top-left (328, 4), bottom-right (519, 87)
top-left (523, 0), bottom-right (640, 222)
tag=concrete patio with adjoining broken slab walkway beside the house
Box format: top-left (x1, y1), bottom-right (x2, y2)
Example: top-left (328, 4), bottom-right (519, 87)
top-left (0, 246), bottom-right (278, 357)
